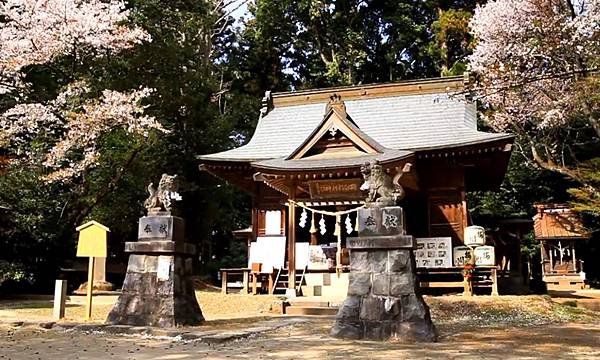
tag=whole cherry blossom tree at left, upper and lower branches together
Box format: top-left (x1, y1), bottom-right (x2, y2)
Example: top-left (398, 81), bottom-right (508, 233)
top-left (0, 0), bottom-right (165, 182)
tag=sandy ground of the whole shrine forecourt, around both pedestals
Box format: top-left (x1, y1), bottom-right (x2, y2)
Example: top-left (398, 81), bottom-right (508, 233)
top-left (0, 292), bottom-right (600, 360)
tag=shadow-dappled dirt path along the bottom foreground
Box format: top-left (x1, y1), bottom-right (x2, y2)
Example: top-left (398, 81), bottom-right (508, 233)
top-left (0, 318), bottom-right (600, 360)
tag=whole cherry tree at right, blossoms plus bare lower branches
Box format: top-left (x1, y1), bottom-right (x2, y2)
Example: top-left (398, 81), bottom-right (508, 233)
top-left (470, 0), bottom-right (600, 207)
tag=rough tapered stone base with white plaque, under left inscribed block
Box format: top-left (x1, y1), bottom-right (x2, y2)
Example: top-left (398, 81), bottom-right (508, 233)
top-left (106, 254), bottom-right (204, 327)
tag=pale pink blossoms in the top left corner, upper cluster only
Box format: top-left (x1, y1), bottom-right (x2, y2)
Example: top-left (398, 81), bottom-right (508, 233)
top-left (0, 0), bottom-right (150, 93)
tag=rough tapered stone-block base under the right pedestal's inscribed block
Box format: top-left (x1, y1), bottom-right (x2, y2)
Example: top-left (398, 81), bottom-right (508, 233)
top-left (330, 249), bottom-right (437, 342)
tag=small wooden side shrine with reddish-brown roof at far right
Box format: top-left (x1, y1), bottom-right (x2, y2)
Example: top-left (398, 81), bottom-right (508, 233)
top-left (533, 204), bottom-right (590, 290)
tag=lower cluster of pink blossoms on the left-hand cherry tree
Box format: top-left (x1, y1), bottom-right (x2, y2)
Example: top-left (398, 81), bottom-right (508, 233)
top-left (0, 83), bottom-right (166, 181)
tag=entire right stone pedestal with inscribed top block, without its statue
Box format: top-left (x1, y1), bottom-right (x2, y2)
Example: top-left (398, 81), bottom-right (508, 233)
top-left (331, 207), bottom-right (437, 342)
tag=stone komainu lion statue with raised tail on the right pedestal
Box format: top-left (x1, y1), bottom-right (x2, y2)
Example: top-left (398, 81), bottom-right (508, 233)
top-left (360, 161), bottom-right (412, 207)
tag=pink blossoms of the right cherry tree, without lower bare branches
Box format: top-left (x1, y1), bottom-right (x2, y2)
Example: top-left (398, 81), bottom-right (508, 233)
top-left (470, 0), bottom-right (600, 136)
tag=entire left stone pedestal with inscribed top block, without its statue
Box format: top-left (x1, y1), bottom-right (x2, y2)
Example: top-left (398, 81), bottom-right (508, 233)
top-left (107, 214), bottom-right (204, 327)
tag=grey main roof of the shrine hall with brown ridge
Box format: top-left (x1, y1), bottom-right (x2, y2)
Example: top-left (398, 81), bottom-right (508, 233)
top-left (198, 77), bottom-right (513, 162)
